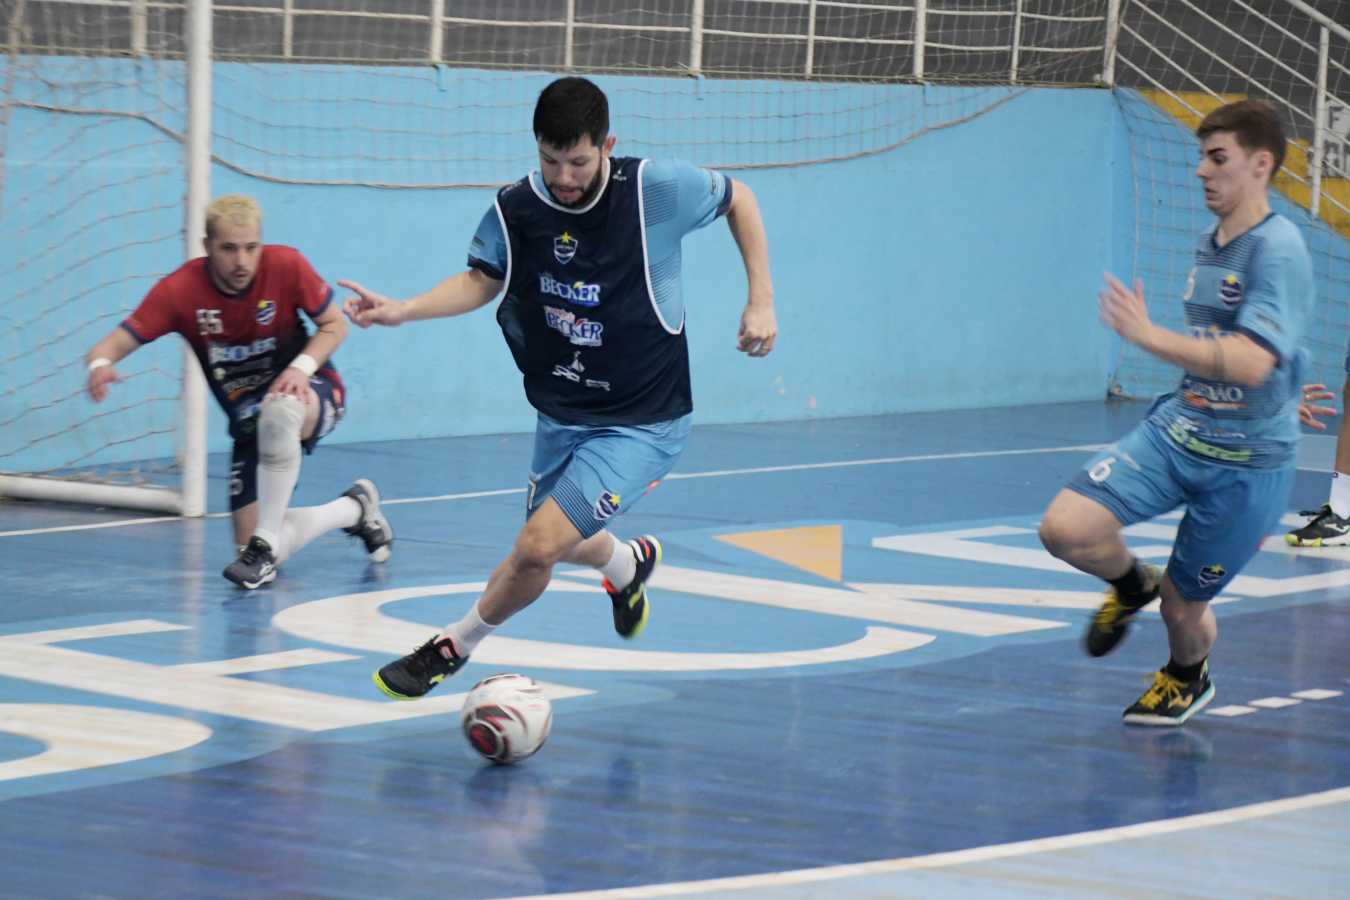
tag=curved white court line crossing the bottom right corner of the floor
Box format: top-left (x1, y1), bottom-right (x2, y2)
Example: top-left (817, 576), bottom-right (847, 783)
top-left (514, 788), bottom-right (1350, 900)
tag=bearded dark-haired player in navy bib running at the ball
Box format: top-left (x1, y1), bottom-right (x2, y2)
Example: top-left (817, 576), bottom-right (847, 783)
top-left (338, 78), bottom-right (778, 699)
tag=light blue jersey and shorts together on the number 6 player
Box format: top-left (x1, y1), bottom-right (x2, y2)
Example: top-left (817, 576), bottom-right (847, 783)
top-left (1068, 213), bottom-right (1312, 600)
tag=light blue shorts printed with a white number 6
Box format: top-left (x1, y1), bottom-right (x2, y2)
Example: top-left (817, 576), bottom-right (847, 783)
top-left (1068, 422), bottom-right (1295, 600)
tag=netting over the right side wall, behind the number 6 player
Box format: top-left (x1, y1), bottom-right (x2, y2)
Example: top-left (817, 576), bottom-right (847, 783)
top-left (1110, 0), bottom-right (1350, 397)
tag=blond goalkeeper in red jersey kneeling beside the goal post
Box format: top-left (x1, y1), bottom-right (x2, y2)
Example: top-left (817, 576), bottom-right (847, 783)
top-left (86, 194), bottom-right (393, 590)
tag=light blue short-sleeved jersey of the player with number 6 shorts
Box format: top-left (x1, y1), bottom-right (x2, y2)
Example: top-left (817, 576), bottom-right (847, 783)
top-left (1148, 213), bottom-right (1314, 468)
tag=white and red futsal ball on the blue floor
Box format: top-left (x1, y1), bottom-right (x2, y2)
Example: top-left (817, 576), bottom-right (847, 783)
top-left (459, 673), bottom-right (554, 765)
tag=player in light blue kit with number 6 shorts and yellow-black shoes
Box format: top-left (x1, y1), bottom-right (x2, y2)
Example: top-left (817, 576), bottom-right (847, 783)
top-left (1041, 100), bottom-right (1314, 726)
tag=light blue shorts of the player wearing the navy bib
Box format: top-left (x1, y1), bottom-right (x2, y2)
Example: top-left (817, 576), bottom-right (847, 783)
top-left (525, 413), bottom-right (693, 538)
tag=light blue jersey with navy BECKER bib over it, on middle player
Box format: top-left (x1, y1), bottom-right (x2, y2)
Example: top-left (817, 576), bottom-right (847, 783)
top-left (468, 158), bottom-right (732, 425)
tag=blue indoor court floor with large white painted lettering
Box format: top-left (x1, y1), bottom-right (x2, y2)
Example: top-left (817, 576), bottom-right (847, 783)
top-left (0, 403), bottom-right (1350, 900)
